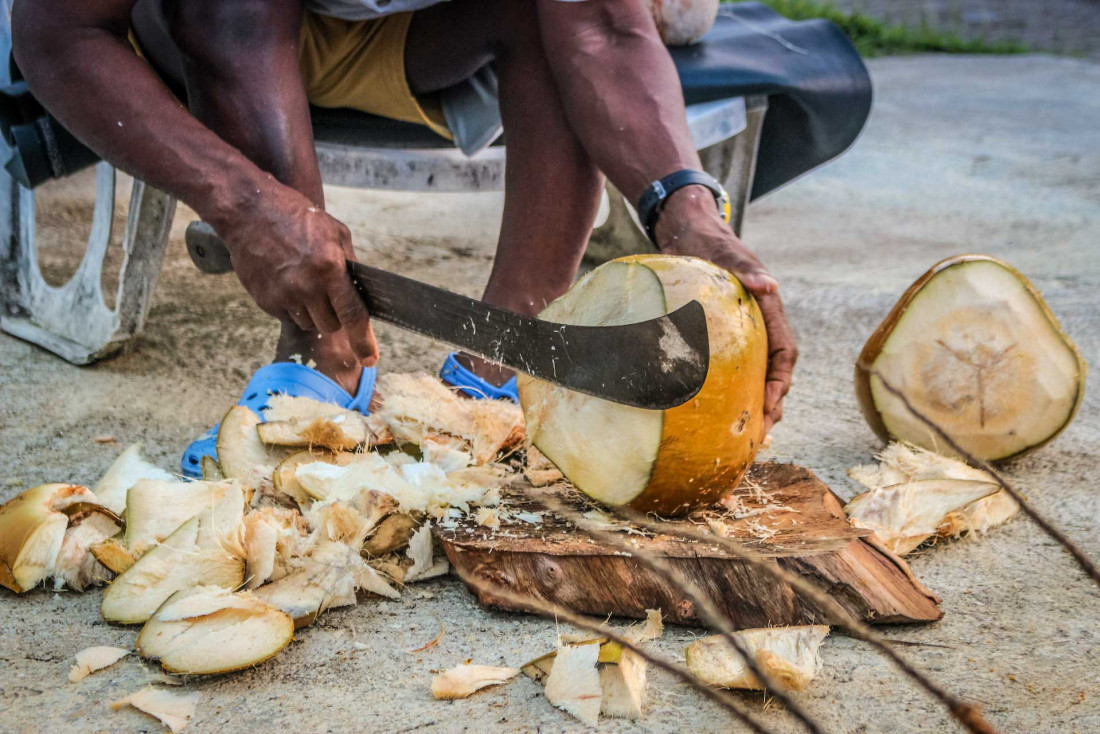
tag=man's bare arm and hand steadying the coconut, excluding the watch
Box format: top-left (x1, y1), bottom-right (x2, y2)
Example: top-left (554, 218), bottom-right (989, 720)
top-left (538, 0), bottom-right (798, 427)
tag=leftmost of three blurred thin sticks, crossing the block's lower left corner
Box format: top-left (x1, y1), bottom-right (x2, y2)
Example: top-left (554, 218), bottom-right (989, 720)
top-left (454, 566), bottom-right (770, 734)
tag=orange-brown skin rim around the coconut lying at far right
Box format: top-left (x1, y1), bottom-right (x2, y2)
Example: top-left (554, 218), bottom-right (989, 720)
top-left (855, 254), bottom-right (1088, 461)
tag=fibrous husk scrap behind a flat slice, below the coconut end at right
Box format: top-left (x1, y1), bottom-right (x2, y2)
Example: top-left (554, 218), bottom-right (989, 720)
top-left (848, 442), bottom-right (1020, 537)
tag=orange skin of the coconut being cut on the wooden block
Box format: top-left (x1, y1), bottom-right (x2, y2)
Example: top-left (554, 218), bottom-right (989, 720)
top-left (620, 255), bottom-right (768, 516)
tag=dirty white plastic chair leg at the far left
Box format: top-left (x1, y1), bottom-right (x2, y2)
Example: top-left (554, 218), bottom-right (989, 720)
top-left (0, 163), bottom-right (176, 364)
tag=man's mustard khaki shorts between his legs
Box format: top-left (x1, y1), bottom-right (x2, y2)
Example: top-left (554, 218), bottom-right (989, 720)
top-left (298, 10), bottom-right (453, 140)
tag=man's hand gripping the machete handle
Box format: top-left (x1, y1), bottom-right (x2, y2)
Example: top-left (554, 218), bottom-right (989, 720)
top-left (211, 180), bottom-right (378, 366)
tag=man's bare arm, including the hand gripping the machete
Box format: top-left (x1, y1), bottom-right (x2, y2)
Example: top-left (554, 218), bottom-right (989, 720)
top-left (12, 0), bottom-right (377, 363)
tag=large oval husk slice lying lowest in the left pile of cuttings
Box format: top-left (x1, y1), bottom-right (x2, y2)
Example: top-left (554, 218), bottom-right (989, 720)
top-left (138, 587), bottom-right (294, 675)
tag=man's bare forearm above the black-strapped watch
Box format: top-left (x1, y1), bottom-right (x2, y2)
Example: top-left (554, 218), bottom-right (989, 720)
top-left (539, 0), bottom-right (701, 201)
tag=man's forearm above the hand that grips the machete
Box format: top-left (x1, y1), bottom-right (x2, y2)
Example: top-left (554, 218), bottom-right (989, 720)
top-left (12, 0), bottom-right (273, 226)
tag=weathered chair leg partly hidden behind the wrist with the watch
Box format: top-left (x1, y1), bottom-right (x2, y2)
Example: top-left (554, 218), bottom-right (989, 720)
top-left (584, 96), bottom-right (768, 265)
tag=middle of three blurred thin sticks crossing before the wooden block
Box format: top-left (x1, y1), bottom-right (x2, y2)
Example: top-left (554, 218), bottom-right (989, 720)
top-left (535, 493), bottom-right (823, 734)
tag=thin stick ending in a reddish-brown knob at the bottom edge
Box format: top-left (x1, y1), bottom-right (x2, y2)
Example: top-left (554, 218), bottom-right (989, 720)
top-left (615, 508), bottom-right (997, 734)
